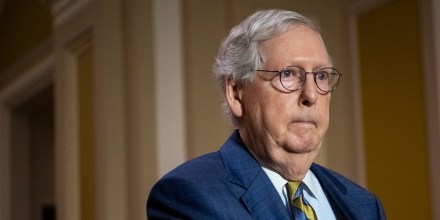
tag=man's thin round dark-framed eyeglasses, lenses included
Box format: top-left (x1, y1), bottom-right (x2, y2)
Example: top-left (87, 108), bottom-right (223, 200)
top-left (257, 66), bottom-right (342, 92)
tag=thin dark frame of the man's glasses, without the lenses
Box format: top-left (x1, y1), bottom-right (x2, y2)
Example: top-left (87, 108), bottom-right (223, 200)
top-left (256, 66), bottom-right (342, 93)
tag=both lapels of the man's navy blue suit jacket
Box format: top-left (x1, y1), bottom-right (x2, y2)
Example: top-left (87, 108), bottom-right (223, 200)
top-left (220, 130), bottom-right (357, 219)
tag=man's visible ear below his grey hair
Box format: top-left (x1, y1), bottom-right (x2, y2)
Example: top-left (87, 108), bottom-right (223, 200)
top-left (225, 77), bottom-right (244, 118)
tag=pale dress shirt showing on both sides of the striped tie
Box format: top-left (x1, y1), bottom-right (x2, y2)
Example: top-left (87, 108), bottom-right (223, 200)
top-left (263, 167), bottom-right (336, 220)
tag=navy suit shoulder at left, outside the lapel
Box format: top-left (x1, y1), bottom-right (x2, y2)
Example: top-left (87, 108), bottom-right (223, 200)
top-left (147, 152), bottom-right (248, 219)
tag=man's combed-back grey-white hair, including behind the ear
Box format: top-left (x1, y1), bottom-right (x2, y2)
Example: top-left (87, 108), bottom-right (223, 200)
top-left (213, 9), bottom-right (319, 126)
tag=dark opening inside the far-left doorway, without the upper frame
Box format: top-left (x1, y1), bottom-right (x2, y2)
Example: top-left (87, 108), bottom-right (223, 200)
top-left (10, 86), bottom-right (55, 220)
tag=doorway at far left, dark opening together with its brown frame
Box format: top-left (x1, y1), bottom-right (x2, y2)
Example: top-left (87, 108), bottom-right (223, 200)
top-left (0, 55), bottom-right (56, 220)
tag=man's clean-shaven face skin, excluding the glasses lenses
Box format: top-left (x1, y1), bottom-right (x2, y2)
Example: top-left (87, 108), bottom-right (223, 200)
top-left (239, 26), bottom-right (330, 172)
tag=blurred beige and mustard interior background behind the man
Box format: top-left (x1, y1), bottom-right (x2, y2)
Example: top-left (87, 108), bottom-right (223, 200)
top-left (0, 0), bottom-right (440, 220)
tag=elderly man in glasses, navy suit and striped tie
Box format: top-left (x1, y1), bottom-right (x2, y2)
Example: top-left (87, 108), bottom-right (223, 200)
top-left (147, 10), bottom-right (385, 220)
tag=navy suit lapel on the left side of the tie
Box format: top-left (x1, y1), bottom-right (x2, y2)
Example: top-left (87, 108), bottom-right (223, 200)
top-left (220, 131), bottom-right (290, 219)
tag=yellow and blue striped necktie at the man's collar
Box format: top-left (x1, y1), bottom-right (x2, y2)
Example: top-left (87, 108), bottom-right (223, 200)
top-left (287, 181), bottom-right (318, 220)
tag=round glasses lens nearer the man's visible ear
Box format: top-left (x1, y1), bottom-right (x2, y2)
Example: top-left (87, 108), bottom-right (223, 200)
top-left (280, 66), bottom-right (305, 91)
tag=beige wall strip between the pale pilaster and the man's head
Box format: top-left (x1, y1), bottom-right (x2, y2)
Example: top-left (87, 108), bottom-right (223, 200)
top-left (183, 0), bottom-right (231, 158)
